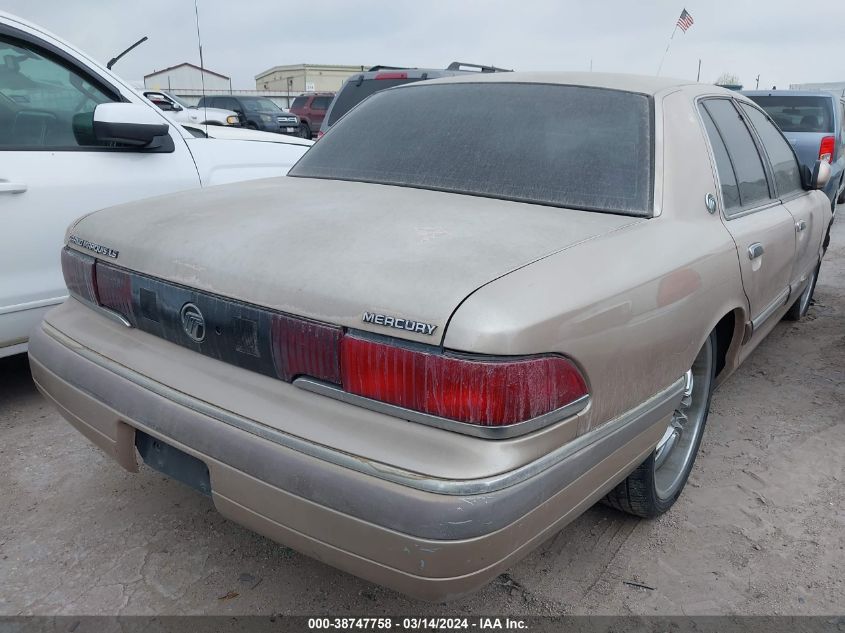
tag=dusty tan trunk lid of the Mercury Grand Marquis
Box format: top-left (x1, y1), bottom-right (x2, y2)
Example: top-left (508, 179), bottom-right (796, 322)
top-left (69, 178), bottom-right (644, 343)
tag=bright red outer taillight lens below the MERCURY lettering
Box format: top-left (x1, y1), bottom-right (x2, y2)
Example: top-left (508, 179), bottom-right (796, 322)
top-left (341, 336), bottom-right (587, 426)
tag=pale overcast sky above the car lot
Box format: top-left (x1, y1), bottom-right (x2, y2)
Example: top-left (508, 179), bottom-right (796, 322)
top-left (0, 0), bottom-right (845, 89)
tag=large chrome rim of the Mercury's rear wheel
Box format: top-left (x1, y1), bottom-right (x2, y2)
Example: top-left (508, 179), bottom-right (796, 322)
top-left (654, 343), bottom-right (713, 500)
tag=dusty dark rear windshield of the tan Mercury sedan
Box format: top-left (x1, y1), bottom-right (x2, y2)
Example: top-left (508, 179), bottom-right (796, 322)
top-left (289, 83), bottom-right (652, 215)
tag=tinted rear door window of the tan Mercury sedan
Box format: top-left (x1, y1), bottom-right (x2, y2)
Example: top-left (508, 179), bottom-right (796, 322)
top-left (704, 99), bottom-right (771, 208)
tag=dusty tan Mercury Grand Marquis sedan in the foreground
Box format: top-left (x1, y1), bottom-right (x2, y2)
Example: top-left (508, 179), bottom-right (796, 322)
top-left (30, 73), bottom-right (831, 600)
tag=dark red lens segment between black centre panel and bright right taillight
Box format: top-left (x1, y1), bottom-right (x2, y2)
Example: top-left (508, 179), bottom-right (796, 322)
top-left (271, 314), bottom-right (343, 384)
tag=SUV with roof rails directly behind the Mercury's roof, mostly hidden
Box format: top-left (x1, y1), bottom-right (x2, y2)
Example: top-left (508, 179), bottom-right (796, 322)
top-left (318, 62), bottom-right (512, 136)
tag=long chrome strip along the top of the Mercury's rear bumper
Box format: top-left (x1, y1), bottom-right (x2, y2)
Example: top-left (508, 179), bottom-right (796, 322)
top-left (42, 323), bottom-right (684, 496)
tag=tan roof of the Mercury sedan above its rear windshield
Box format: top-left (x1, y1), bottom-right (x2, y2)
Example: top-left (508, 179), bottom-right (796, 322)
top-left (403, 72), bottom-right (704, 95)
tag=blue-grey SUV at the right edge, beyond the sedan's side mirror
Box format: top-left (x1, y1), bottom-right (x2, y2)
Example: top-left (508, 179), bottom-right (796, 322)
top-left (743, 90), bottom-right (845, 208)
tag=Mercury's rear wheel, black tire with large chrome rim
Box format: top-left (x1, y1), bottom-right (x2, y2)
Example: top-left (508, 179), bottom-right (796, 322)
top-left (604, 332), bottom-right (716, 518)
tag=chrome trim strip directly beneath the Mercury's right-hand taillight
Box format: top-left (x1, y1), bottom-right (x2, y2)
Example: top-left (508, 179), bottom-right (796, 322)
top-left (293, 376), bottom-right (590, 440)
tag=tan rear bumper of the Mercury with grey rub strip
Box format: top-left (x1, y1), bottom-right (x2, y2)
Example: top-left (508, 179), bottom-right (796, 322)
top-left (30, 316), bottom-right (681, 601)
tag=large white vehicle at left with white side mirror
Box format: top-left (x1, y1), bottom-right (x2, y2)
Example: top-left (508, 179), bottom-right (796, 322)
top-left (0, 13), bottom-right (307, 357)
